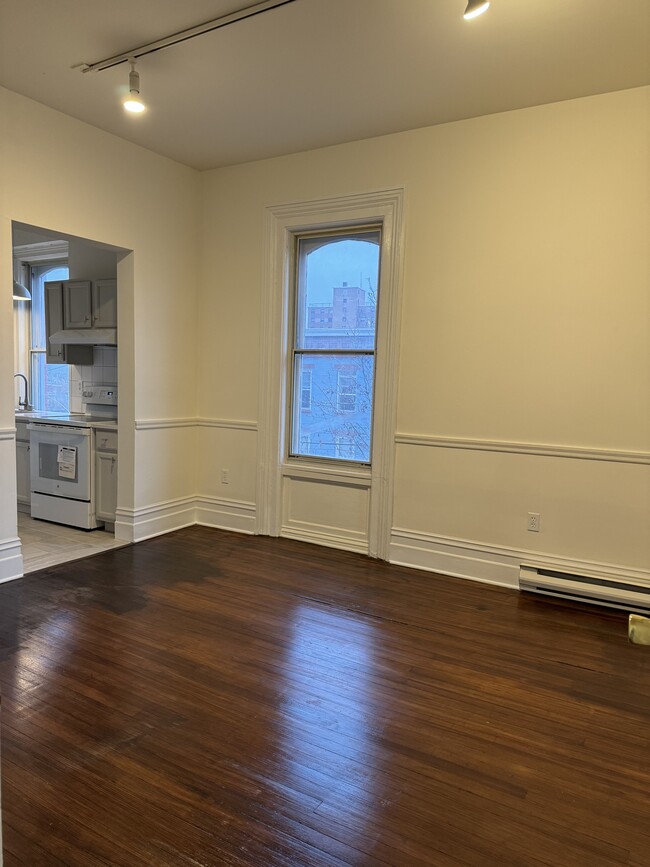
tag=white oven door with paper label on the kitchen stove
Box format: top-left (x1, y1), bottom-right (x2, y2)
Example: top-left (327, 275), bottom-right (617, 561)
top-left (27, 422), bottom-right (91, 502)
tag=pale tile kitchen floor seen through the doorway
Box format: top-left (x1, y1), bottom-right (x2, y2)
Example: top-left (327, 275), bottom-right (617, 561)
top-left (18, 512), bottom-right (128, 574)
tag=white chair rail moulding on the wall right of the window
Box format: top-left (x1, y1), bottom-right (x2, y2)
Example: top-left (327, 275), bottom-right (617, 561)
top-left (395, 433), bottom-right (650, 464)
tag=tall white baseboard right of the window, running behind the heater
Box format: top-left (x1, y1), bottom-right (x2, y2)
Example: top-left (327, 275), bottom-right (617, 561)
top-left (389, 527), bottom-right (650, 588)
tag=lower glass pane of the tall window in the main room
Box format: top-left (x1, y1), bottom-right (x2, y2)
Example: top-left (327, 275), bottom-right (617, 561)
top-left (291, 353), bottom-right (374, 463)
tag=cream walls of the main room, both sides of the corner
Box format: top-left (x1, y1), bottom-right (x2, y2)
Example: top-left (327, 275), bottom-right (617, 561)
top-left (0, 88), bottom-right (650, 583)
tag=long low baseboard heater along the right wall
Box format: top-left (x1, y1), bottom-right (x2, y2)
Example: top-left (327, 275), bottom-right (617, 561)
top-left (519, 564), bottom-right (650, 615)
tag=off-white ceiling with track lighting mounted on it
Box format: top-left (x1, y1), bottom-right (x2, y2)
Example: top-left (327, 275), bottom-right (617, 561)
top-left (0, 0), bottom-right (650, 169)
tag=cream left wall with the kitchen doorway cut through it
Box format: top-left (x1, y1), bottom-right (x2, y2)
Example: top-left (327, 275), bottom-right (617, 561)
top-left (0, 89), bottom-right (200, 579)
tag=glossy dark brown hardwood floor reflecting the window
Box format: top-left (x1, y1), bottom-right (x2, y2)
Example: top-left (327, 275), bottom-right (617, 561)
top-left (0, 527), bottom-right (650, 867)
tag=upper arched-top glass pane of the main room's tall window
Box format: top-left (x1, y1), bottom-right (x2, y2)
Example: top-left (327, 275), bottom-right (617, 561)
top-left (296, 230), bottom-right (381, 349)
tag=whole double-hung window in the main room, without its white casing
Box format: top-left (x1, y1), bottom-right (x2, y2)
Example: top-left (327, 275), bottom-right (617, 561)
top-left (289, 226), bottom-right (381, 464)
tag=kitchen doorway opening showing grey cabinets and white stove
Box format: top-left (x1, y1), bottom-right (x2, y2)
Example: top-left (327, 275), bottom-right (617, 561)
top-left (12, 224), bottom-right (128, 574)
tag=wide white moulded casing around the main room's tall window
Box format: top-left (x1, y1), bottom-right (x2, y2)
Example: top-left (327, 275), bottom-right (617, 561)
top-left (256, 189), bottom-right (404, 559)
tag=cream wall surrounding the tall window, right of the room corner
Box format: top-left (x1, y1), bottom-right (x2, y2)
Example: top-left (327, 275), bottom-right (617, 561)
top-left (198, 88), bottom-right (650, 583)
